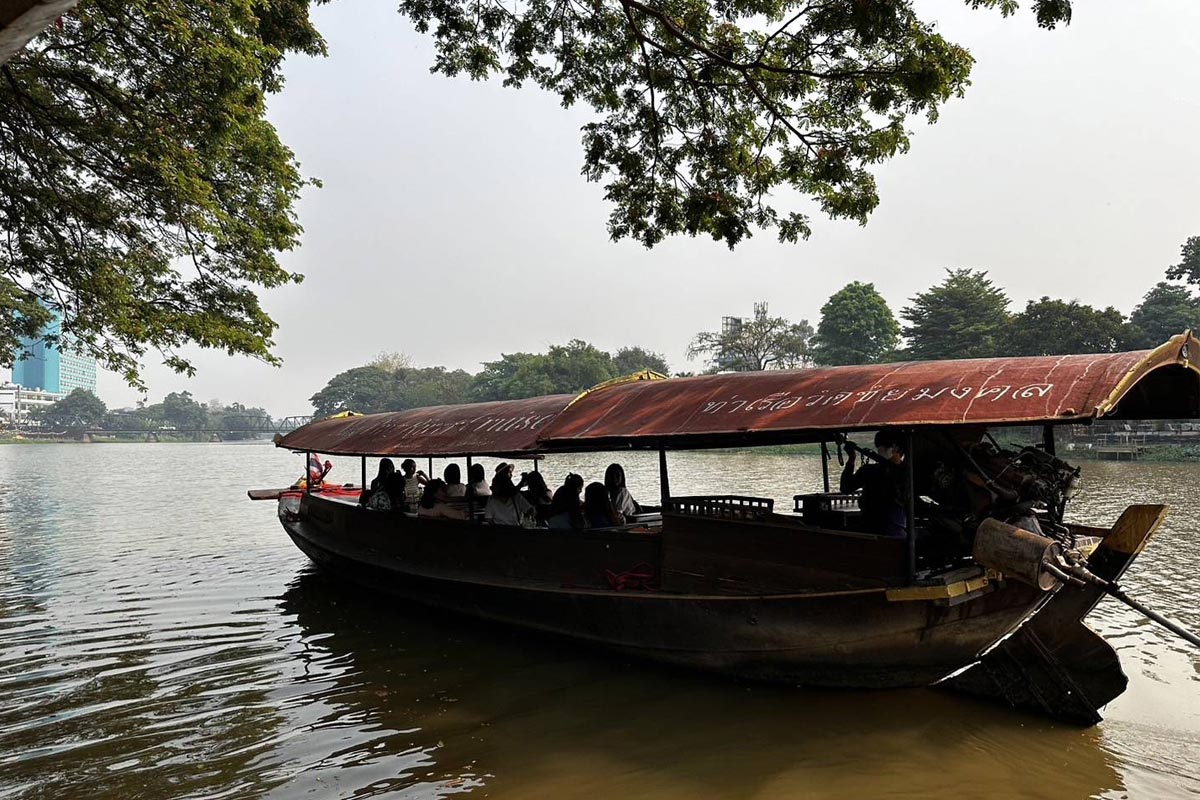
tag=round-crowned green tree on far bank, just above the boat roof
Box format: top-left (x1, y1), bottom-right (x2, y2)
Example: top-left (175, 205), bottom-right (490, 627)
top-left (812, 281), bottom-right (900, 366)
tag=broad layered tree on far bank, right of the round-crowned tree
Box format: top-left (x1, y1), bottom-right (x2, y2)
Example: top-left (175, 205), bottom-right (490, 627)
top-left (900, 270), bottom-right (1009, 361)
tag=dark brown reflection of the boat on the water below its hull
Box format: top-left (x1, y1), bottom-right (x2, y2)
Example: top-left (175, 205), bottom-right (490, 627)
top-left (282, 575), bottom-right (1122, 798)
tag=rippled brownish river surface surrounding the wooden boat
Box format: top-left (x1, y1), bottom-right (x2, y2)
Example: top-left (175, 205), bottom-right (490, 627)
top-left (0, 444), bottom-right (1200, 800)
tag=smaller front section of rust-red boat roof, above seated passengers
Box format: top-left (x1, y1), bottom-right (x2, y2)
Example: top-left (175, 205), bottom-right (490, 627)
top-left (278, 395), bottom-right (575, 456)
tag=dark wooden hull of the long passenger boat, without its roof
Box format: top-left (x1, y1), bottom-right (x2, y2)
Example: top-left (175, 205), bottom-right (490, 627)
top-left (283, 497), bottom-right (1046, 688)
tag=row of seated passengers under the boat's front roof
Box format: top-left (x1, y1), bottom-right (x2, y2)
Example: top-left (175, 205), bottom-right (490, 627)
top-left (359, 458), bottom-right (641, 530)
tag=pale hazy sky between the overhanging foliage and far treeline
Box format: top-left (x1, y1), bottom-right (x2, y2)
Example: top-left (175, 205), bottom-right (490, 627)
top-left (88, 0), bottom-right (1200, 416)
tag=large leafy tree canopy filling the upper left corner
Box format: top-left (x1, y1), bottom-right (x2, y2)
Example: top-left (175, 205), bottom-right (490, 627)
top-left (0, 0), bottom-right (324, 385)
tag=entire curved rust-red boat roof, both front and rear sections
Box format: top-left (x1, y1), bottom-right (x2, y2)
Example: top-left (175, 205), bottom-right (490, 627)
top-left (278, 331), bottom-right (1200, 458)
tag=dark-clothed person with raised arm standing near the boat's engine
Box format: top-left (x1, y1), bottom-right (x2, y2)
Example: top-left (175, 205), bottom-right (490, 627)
top-left (840, 428), bottom-right (908, 539)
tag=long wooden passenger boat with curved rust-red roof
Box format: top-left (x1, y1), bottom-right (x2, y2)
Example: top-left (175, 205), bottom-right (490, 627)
top-left (255, 333), bottom-right (1200, 723)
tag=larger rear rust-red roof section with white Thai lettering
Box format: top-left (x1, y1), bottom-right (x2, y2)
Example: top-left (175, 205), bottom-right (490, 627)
top-left (541, 335), bottom-right (1200, 450)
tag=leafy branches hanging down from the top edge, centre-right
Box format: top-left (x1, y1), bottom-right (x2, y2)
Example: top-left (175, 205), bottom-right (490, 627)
top-left (400, 0), bottom-right (1072, 247)
